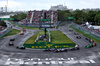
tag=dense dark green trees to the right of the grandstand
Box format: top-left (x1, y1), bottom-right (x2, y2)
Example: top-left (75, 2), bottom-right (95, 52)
top-left (58, 10), bottom-right (100, 25)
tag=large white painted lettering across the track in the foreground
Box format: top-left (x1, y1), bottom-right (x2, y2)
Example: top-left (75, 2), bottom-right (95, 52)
top-left (5, 58), bottom-right (96, 65)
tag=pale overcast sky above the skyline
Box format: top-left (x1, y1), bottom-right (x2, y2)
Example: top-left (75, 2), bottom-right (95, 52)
top-left (0, 0), bottom-right (100, 11)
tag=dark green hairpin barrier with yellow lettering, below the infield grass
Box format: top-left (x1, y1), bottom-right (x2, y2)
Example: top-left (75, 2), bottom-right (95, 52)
top-left (23, 42), bottom-right (76, 49)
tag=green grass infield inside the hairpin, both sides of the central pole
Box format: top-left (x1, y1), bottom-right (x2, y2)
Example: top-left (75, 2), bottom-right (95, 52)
top-left (24, 31), bottom-right (74, 44)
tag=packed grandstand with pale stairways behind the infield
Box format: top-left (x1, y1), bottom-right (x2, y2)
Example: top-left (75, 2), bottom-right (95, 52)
top-left (24, 10), bottom-right (57, 24)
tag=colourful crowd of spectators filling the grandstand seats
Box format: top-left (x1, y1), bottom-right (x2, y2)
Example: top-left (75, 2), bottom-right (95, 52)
top-left (23, 10), bottom-right (57, 23)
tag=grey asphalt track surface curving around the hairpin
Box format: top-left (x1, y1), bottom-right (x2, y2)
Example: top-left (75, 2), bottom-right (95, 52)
top-left (0, 21), bottom-right (100, 66)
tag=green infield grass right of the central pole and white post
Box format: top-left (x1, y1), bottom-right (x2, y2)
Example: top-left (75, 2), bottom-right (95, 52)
top-left (50, 31), bottom-right (74, 43)
